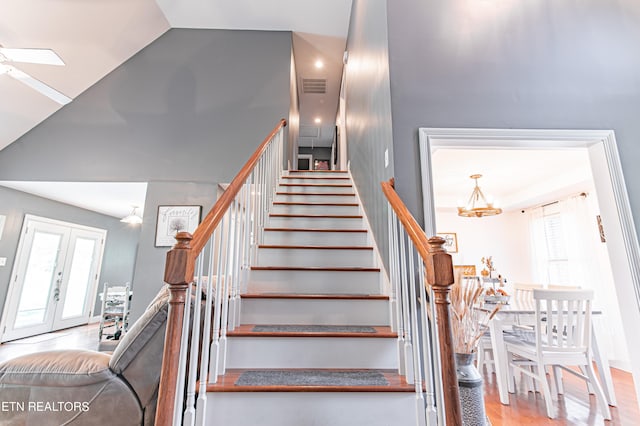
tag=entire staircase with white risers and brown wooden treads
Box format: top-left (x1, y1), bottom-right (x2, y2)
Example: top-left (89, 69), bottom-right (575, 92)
top-left (206, 171), bottom-right (418, 426)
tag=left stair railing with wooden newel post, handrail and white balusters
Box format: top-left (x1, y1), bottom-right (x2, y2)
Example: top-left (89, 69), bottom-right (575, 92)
top-left (155, 119), bottom-right (287, 426)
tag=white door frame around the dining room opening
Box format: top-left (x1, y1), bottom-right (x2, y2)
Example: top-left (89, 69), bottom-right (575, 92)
top-left (419, 128), bottom-right (640, 406)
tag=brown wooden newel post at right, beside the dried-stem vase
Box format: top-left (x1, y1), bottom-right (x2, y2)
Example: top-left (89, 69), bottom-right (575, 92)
top-left (425, 237), bottom-right (462, 425)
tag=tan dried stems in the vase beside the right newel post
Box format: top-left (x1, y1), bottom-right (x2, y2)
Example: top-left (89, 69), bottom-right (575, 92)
top-left (451, 277), bottom-right (502, 354)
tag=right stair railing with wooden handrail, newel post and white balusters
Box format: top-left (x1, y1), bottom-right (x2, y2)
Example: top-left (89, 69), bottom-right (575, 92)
top-left (381, 179), bottom-right (462, 425)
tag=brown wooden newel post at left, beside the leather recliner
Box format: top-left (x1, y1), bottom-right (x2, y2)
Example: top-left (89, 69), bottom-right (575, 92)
top-left (155, 232), bottom-right (194, 426)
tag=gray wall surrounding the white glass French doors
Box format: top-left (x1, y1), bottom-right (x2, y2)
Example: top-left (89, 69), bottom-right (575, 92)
top-left (0, 187), bottom-right (140, 315)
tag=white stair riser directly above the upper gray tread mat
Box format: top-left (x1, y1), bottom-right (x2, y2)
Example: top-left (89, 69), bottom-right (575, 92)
top-left (240, 298), bottom-right (389, 325)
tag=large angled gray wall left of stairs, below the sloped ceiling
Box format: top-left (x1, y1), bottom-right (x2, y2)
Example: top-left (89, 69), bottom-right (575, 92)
top-left (0, 29), bottom-right (297, 319)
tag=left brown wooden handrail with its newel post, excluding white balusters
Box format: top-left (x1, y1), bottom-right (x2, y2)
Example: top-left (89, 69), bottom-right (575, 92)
top-left (155, 118), bottom-right (287, 426)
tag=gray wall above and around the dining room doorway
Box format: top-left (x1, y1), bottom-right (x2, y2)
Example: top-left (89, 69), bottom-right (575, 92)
top-left (387, 0), bottom-right (640, 236)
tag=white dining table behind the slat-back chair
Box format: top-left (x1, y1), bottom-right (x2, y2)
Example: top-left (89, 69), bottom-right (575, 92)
top-left (489, 300), bottom-right (617, 406)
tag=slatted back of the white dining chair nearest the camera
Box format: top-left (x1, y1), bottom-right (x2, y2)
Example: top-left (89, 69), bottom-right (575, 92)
top-left (533, 289), bottom-right (593, 352)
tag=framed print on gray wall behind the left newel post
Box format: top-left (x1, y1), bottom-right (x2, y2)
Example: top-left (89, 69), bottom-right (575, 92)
top-left (155, 206), bottom-right (202, 247)
